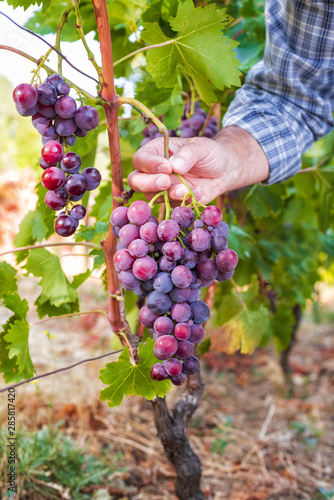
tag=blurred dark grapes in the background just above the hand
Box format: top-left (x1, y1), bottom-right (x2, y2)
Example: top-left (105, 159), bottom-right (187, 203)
top-left (140, 101), bottom-right (218, 146)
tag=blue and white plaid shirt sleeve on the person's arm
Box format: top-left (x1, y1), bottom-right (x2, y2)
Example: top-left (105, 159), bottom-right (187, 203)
top-left (223, 0), bottom-right (334, 184)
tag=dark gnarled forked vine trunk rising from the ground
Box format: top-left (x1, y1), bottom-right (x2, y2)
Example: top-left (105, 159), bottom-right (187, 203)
top-left (152, 373), bottom-right (205, 500)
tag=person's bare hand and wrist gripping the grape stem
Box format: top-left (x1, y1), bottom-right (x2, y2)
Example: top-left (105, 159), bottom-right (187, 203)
top-left (128, 126), bottom-right (269, 204)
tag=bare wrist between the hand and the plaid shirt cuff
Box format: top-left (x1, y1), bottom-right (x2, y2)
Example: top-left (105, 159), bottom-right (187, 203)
top-left (213, 125), bottom-right (269, 192)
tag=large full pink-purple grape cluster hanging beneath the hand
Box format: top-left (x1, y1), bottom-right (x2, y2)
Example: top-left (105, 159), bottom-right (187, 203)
top-left (110, 200), bottom-right (238, 385)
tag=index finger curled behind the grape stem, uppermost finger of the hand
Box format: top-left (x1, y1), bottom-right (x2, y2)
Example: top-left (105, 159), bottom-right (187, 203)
top-left (132, 137), bottom-right (196, 174)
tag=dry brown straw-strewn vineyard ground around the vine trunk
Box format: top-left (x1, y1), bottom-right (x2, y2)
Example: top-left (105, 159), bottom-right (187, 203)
top-left (1, 280), bottom-right (334, 500)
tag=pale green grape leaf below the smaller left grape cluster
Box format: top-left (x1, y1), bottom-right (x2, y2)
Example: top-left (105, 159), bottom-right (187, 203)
top-left (25, 248), bottom-right (78, 307)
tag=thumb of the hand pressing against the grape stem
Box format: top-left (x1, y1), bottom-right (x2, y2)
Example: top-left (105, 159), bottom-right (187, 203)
top-left (169, 137), bottom-right (208, 175)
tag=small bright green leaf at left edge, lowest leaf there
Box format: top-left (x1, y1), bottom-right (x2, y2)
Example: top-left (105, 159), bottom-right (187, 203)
top-left (4, 319), bottom-right (35, 376)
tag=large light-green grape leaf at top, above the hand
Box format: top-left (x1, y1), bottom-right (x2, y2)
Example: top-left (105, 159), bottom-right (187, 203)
top-left (141, 0), bottom-right (241, 105)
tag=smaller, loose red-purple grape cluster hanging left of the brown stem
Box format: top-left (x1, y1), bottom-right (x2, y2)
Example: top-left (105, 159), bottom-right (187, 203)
top-left (13, 77), bottom-right (101, 236)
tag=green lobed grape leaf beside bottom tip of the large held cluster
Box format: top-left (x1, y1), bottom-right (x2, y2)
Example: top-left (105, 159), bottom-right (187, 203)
top-left (100, 339), bottom-right (171, 408)
